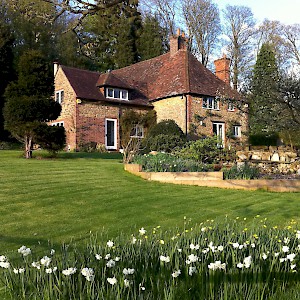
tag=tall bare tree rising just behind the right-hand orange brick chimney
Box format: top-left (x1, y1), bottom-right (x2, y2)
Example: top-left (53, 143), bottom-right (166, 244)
top-left (223, 5), bottom-right (255, 90)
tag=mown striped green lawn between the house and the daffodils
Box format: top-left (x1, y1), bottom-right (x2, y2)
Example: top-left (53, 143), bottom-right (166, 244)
top-left (0, 150), bottom-right (300, 254)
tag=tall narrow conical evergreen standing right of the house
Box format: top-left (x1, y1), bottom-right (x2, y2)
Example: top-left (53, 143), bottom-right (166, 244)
top-left (249, 43), bottom-right (282, 134)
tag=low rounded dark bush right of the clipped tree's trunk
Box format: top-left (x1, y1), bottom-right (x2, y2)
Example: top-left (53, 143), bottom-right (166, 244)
top-left (34, 123), bottom-right (66, 154)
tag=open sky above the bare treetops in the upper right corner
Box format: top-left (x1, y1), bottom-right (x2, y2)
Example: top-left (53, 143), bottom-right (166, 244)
top-left (217, 0), bottom-right (300, 25)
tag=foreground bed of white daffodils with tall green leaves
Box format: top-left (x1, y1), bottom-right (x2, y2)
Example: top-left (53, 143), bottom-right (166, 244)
top-left (0, 215), bottom-right (300, 300)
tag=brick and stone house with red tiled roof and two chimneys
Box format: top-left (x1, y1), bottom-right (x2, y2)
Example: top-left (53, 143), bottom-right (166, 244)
top-left (51, 31), bottom-right (248, 150)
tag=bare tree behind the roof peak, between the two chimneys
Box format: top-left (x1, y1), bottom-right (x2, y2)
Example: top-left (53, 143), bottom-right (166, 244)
top-left (182, 0), bottom-right (221, 67)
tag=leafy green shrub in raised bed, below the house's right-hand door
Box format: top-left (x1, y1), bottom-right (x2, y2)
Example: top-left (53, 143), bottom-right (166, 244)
top-left (176, 136), bottom-right (234, 164)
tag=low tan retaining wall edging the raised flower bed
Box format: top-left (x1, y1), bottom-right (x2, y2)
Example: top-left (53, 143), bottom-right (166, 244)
top-left (124, 164), bottom-right (300, 192)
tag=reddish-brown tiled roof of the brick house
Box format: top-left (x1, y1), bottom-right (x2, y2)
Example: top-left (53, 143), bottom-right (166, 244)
top-left (62, 50), bottom-right (240, 105)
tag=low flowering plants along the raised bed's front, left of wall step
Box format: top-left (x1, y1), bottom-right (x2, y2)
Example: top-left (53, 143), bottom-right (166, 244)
top-left (133, 153), bottom-right (213, 172)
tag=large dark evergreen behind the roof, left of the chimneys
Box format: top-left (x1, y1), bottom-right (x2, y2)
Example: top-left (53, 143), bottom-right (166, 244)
top-left (80, 0), bottom-right (141, 71)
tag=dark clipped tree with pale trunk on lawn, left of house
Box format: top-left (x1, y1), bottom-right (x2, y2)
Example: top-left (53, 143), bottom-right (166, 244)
top-left (4, 50), bottom-right (61, 158)
